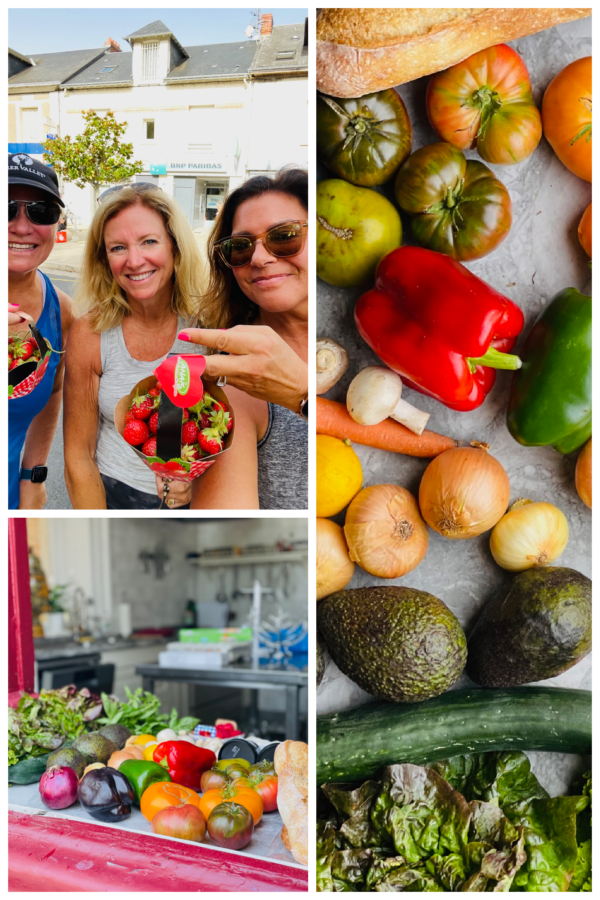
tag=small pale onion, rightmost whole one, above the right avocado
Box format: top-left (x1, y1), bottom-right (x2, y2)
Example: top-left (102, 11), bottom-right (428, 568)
top-left (490, 500), bottom-right (569, 572)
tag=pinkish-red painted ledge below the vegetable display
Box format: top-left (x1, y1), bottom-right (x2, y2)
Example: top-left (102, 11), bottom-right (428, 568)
top-left (8, 811), bottom-right (308, 892)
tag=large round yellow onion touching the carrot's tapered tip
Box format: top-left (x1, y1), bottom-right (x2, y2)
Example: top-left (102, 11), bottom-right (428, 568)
top-left (419, 441), bottom-right (510, 540)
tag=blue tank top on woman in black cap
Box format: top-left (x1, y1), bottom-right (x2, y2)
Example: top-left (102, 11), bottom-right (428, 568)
top-left (8, 271), bottom-right (62, 509)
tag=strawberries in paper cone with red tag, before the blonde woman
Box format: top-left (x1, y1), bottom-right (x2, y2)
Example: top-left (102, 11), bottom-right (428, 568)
top-left (114, 355), bottom-right (235, 481)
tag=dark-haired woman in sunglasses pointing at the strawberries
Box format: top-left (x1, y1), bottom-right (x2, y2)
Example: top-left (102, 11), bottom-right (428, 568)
top-left (179, 168), bottom-right (308, 509)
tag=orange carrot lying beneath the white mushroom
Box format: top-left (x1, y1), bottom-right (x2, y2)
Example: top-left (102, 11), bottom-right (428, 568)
top-left (317, 397), bottom-right (457, 458)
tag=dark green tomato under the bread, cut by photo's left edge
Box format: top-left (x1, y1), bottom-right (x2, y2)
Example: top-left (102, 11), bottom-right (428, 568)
top-left (317, 88), bottom-right (412, 187)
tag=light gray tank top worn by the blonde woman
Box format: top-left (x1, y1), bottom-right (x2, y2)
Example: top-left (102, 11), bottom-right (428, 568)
top-left (96, 316), bottom-right (205, 495)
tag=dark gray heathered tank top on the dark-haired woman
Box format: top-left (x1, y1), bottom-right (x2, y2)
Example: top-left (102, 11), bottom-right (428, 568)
top-left (258, 403), bottom-right (308, 509)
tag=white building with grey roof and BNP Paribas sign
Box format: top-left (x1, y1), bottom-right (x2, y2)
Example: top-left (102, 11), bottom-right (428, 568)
top-left (9, 17), bottom-right (308, 229)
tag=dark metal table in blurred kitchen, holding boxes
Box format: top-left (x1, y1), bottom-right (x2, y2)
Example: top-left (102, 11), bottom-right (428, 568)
top-left (135, 662), bottom-right (308, 741)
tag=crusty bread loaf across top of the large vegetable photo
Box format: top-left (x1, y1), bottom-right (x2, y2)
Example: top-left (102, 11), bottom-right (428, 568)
top-left (317, 8), bottom-right (592, 97)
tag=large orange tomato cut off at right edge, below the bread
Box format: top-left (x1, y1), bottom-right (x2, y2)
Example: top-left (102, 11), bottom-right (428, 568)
top-left (542, 56), bottom-right (592, 181)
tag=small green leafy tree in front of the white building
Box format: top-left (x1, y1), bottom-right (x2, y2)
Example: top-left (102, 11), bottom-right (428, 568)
top-left (42, 109), bottom-right (144, 199)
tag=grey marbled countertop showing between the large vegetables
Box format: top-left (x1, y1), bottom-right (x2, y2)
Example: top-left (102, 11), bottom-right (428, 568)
top-left (317, 19), bottom-right (591, 793)
